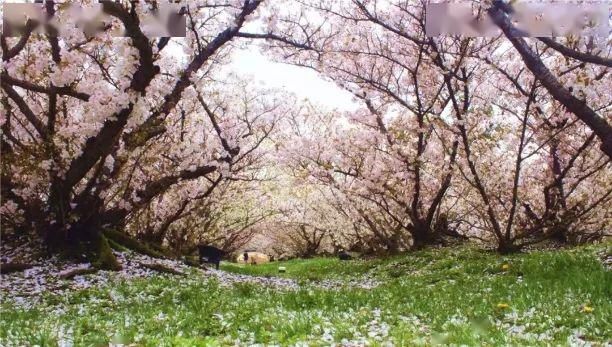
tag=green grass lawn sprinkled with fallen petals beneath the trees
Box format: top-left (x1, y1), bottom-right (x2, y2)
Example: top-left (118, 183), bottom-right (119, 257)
top-left (0, 244), bottom-right (612, 346)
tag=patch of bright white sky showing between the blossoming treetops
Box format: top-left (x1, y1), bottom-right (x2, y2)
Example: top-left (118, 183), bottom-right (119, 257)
top-left (227, 45), bottom-right (357, 111)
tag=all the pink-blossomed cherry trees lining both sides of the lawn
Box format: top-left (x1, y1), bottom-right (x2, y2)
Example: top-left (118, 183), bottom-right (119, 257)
top-left (0, 0), bottom-right (612, 268)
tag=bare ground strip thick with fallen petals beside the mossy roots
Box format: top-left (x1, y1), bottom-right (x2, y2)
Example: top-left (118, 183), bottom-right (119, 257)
top-left (0, 247), bottom-right (379, 308)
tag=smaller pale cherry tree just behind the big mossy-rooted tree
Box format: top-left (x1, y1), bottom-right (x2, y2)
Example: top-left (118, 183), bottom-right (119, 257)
top-left (123, 76), bottom-right (292, 251)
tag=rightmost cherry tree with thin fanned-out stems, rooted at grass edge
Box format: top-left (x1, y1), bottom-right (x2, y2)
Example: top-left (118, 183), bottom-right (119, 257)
top-left (464, 42), bottom-right (610, 249)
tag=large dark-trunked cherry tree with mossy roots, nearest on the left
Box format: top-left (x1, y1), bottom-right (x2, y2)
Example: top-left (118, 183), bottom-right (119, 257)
top-left (0, 0), bottom-right (272, 267)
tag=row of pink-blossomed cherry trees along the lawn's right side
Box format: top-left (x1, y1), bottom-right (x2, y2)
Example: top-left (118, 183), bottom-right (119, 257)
top-left (258, 0), bottom-right (612, 252)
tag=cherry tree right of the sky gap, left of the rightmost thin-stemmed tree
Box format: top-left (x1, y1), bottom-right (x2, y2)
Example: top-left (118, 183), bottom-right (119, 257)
top-left (246, 1), bottom-right (480, 248)
